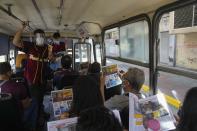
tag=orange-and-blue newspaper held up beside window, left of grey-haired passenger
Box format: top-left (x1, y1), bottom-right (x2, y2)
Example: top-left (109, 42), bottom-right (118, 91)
top-left (102, 65), bottom-right (122, 89)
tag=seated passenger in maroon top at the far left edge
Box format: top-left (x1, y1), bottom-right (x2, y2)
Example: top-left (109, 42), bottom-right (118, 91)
top-left (0, 62), bottom-right (36, 128)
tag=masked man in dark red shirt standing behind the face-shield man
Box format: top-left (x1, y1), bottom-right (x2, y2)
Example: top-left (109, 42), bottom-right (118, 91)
top-left (50, 32), bottom-right (66, 71)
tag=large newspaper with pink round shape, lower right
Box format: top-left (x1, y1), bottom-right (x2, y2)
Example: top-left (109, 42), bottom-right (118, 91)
top-left (129, 93), bottom-right (176, 131)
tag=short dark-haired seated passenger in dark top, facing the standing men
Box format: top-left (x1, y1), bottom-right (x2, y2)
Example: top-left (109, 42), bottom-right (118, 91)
top-left (53, 55), bottom-right (78, 90)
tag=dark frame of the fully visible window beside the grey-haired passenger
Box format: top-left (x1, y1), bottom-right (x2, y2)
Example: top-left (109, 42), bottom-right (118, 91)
top-left (101, 14), bottom-right (154, 90)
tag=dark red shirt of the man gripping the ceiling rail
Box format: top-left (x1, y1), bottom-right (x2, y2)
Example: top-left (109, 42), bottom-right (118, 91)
top-left (23, 41), bottom-right (48, 84)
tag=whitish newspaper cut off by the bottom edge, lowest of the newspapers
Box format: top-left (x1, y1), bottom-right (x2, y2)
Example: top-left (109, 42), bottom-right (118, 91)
top-left (47, 117), bottom-right (77, 131)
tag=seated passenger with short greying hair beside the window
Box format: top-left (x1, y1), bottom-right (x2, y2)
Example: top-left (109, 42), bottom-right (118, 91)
top-left (105, 68), bottom-right (145, 110)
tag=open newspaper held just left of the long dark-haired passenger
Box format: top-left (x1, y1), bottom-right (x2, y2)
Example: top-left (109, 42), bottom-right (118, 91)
top-left (51, 89), bottom-right (73, 117)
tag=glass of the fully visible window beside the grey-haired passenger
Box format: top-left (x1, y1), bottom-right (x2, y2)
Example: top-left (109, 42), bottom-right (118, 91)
top-left (105, 17), bottom-right (150, 89)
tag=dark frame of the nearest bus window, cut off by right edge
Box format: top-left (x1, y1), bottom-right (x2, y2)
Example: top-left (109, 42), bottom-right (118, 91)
top-left (152, 0), bottom-right (197, 94)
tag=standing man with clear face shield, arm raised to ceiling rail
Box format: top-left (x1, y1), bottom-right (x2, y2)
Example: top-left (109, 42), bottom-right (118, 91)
top-left (13, 23), bottom-right (52, 127)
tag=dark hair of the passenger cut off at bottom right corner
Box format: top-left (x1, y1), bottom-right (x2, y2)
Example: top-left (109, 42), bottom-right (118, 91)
top-left (178, 87), bottom-right (197, 131)
